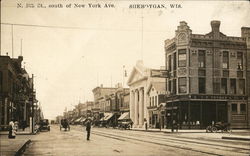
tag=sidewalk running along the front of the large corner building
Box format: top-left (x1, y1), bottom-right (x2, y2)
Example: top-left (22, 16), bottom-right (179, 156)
top-left (131, 128), bottom-right (250, 141)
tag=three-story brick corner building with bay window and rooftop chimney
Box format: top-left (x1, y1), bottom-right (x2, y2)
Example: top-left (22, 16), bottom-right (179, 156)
top-left (165, 21), bottom-right (250, 129)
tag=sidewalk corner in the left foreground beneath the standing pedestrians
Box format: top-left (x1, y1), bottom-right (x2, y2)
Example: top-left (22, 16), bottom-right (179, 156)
top-left (0, 135), bottom-right (31, 156)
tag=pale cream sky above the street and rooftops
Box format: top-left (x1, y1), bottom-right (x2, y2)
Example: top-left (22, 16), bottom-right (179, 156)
top-left (1, 0), bottom-right (250, 119)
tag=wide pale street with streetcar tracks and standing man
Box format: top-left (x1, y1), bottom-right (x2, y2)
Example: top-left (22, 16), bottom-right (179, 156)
top-left (20, 125), bottom-right (250, 156)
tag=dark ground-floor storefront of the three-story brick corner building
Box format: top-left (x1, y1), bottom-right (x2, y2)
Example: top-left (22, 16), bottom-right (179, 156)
top-left (166, 95), bottom-right (247, 129)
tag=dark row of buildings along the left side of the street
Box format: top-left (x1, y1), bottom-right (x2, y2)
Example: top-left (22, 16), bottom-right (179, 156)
top-left (0, 56), bottom-right (36, 129)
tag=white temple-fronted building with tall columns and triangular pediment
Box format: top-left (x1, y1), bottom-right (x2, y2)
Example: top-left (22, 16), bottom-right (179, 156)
top-left (127, 61), bottom-right (165, 127)
